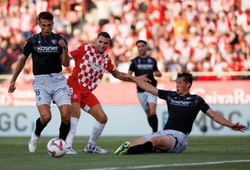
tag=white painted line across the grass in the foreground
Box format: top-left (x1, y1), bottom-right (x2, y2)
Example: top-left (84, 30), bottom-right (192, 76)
top-left (83, 160), bottom-right (250, 170)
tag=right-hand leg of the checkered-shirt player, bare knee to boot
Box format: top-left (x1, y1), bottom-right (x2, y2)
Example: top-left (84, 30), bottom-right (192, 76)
top-left (84, 103), bottom-right (108, 153)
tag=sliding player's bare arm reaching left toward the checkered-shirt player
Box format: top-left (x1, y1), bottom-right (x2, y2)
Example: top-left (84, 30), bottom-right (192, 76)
top-left (121, 73), bottom-right (159, 96)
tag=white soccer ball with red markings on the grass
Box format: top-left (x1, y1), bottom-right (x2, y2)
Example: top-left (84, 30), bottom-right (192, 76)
top-left (47, 138), bottom-right (67, 158)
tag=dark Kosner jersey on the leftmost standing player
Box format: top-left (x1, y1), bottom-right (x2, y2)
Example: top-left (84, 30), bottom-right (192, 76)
top-left (23, 33), bottom-right (67, 75)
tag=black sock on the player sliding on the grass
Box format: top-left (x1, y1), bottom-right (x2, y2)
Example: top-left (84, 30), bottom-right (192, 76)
top-left (127, 141), bottom-right (153, 154)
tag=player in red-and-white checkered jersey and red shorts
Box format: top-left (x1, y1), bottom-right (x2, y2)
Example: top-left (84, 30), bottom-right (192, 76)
top-left (66, 32), bottom-right (132, 154)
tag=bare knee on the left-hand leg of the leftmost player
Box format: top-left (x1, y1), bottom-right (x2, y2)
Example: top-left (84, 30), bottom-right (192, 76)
top-left (37, 104), bottom-right (51, 125)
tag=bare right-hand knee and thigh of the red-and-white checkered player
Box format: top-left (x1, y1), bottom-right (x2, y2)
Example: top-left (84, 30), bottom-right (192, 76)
top-left (88, 103), bottom-right (108, 123)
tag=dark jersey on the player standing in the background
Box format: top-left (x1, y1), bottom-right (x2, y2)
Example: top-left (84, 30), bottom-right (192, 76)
top-left (129, 56), bottom-right (158, 92)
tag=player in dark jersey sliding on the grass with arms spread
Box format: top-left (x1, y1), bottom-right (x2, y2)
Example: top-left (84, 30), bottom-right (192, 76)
top-left (114, 71), bottom-right (247, 155)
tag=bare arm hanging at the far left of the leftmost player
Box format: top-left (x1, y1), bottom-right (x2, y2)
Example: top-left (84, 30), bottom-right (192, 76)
top-left (8, 55), bottom-right (28, 93)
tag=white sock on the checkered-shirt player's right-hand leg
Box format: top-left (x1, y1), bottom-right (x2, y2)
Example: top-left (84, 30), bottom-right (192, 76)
top-left (88, 121), bottom-right (106, 147)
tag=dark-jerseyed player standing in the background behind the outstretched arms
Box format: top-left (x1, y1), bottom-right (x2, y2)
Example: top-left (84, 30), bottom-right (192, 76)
top-left (128, 40), bottom-right (162, 132)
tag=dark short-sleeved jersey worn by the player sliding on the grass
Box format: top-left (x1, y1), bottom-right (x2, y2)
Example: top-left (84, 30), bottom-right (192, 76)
top-left (158, 90), bottom-right (210, 134)
